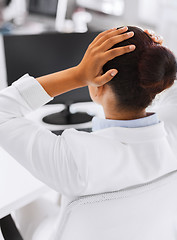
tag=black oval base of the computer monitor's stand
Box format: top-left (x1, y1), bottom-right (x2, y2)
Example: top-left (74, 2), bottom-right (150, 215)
top-left (42, 104), bottom-right (93, 125)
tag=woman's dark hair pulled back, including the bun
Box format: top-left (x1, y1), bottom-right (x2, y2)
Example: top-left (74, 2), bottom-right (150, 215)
top-left (103, 26), bottom-right (177, 110)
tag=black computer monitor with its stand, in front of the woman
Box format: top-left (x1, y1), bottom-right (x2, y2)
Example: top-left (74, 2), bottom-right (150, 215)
top-left (4, 32), bottom-right (98, 125)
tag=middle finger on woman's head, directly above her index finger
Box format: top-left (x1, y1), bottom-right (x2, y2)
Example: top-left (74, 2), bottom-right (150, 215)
top-left (99, 32), bottom-right (134, 51)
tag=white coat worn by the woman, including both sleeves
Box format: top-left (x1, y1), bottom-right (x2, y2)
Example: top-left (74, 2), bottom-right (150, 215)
top-left (0, 75), bottom-right (177, 239)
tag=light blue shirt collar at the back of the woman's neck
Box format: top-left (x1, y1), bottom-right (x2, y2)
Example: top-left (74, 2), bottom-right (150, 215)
top-left (92, 113), bottom-right (159, 132)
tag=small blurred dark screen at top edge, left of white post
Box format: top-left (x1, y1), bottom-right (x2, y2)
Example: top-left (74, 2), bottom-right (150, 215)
top-left (29, 0), bottom-right (58, 17)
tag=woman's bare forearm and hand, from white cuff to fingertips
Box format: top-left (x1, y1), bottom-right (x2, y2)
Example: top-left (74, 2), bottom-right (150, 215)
top-left (37, 27), bottom-right (136, 97)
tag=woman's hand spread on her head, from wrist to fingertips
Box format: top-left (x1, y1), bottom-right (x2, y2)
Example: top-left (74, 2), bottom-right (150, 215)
top-left (77, 27), bottom-right (136, 87)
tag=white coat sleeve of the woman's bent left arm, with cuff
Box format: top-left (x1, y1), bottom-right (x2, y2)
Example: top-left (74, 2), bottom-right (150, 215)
top-left (0, 74), bottom-right (85, 196)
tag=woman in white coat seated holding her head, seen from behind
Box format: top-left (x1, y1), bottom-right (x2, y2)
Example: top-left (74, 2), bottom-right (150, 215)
top-left (0, 27), bottom-right (177, 239)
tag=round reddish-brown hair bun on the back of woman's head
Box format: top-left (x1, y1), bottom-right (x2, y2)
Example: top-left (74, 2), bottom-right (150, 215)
top-left (138, 44), bottom-right (177, 94)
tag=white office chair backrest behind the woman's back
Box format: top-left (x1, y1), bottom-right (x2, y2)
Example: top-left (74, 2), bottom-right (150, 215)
top-left (56, 171), bottom-right (177, 240)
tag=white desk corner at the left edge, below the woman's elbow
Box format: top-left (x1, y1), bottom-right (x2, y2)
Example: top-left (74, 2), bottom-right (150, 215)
top-left (0, 148), bottom-right (50, 219)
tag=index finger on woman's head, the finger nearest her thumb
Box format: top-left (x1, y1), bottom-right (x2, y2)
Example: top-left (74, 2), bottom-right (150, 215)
top-left (103, 45), bottom-right (136, 63)
